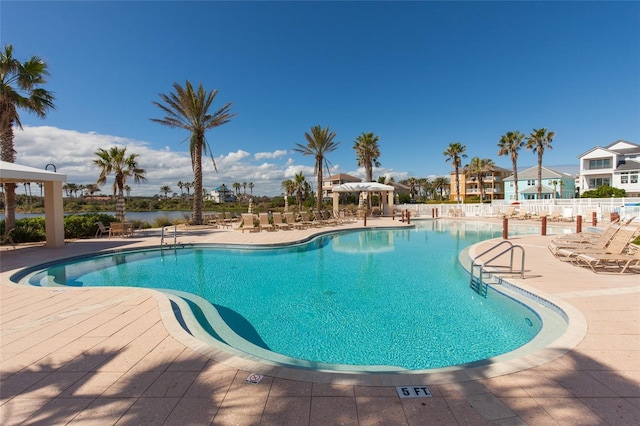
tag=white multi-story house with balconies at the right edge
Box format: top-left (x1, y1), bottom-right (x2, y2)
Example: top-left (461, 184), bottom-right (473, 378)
top-left (578, 140), bottom-right (640, 197)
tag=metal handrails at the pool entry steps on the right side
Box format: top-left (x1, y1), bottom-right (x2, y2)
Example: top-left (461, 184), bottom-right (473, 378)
top-left (469, 240), bottom-right (524, 297)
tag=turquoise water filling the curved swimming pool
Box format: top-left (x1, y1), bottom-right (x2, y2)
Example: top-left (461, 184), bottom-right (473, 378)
top-left (23, 220), bottom-right (542, 370)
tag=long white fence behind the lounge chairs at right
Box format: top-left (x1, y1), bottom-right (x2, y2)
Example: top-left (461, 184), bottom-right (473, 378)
top-left (394, 197), bottom-right (640, 221)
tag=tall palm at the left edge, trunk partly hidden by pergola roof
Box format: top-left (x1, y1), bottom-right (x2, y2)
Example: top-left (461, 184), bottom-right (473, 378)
top-left (0, 44), bottom-right (55, 235)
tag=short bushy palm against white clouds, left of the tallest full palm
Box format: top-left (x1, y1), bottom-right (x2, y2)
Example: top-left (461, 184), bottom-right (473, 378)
top-left (93, 146), bottom-right (147, 221)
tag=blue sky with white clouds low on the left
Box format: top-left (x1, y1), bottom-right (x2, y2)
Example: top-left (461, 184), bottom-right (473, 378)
top-left (0, 0), bottom-right (640, 195)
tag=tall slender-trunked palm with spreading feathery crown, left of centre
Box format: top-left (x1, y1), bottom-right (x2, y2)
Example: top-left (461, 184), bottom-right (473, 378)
top-left (151, 80), bottom-right (236, 225)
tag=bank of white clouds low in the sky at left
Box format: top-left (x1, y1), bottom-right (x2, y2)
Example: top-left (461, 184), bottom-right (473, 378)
top-left (9, 126), bottom-right (296, 195)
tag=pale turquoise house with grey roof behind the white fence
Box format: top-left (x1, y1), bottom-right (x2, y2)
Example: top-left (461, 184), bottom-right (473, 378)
top-left (504, 166), bottom-right (576, 201)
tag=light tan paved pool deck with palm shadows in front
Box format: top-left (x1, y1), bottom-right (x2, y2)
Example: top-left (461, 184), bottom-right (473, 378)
top-left (0, 218), bottom-right (640, 426)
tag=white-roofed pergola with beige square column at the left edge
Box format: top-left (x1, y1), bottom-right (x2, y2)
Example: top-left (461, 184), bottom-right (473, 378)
top-left (0, 161), bottom-right (67, 247)
